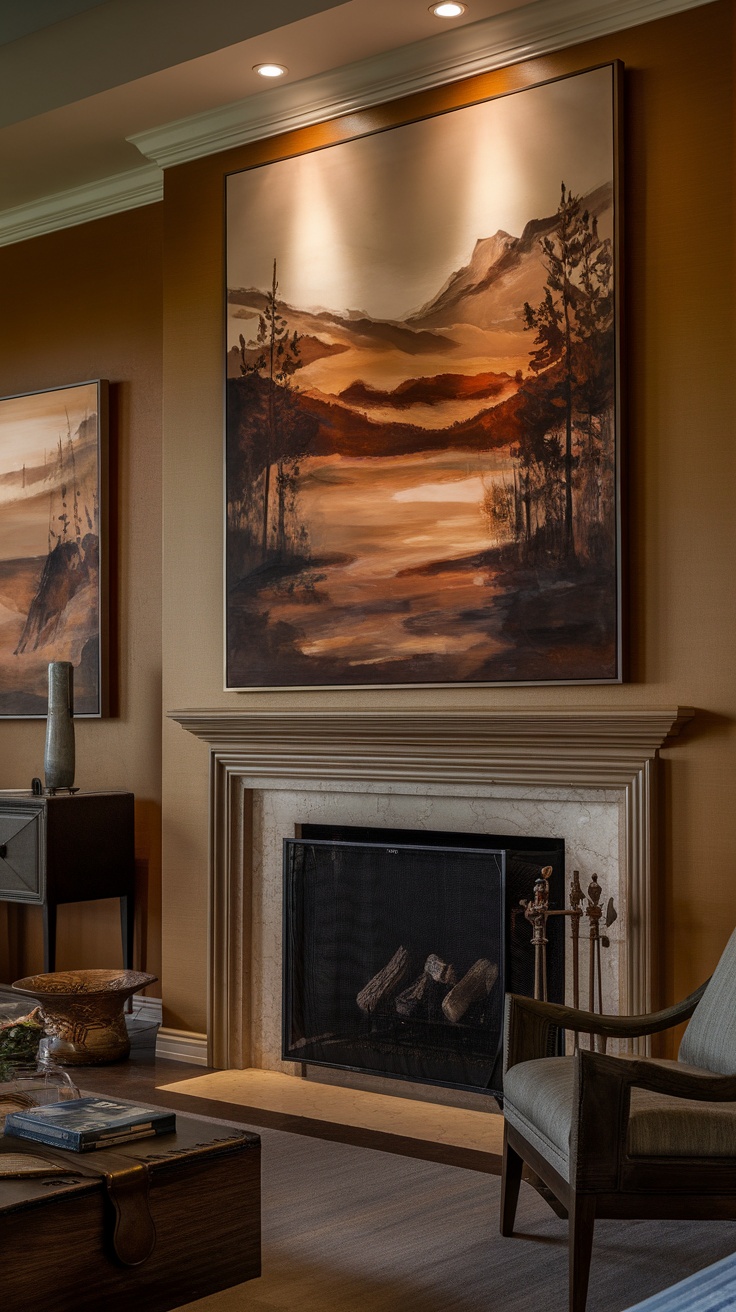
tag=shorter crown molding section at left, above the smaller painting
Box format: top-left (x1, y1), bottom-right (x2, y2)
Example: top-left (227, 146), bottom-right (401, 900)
top-left (0, 164), bottom-right (164, 247)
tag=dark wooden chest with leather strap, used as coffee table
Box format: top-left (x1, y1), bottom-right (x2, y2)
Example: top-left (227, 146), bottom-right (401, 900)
top-left (0, 1115), bottom-right (261, 1312)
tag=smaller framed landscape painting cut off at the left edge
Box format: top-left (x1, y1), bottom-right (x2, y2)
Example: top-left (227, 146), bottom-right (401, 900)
top-left (0, 379), bottom-right (108, 719)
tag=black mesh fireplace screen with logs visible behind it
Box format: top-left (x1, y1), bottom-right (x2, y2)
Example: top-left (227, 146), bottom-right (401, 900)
top-left (283, 825), bottom-right (564, 1093)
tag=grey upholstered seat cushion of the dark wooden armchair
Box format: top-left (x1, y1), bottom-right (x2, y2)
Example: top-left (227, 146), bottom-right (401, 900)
top-left (504, 1057), bottom-right (736, 1179)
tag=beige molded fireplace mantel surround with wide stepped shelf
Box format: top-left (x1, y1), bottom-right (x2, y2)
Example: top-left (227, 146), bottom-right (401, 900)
top-left (169, 707), bottom-right (693, 1067)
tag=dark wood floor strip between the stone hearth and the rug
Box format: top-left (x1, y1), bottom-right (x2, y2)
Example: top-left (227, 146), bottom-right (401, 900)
top-left (73, 1033), bottom-right (509, 1176)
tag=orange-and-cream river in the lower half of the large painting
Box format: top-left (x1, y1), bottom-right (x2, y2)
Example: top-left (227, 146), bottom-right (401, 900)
top-left (263, 451), bottom-right (512, 677)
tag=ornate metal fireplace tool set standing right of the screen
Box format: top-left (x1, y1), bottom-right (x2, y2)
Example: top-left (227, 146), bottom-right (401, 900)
top-left (521, 866), bottom-right (618, 1046)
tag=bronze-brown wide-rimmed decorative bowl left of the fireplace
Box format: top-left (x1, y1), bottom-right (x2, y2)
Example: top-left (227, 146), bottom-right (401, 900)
top-left (13, 971), bottom-right (157, 1065)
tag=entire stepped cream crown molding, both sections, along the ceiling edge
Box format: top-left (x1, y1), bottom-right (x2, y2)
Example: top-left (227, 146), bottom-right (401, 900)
top-left (0, 0), bottom-right (712, 245)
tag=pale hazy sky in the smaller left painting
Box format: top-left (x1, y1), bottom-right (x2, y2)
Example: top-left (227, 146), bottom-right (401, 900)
top-left (0, 383), bottom-right (97, 475)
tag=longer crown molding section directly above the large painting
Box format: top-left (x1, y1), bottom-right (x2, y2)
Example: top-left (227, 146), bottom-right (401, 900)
top-left (127, 0), bottom-right (712, 168)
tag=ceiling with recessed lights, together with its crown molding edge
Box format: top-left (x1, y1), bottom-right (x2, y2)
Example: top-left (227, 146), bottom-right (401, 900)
top-left (0, 0), bottom-right (708, 241)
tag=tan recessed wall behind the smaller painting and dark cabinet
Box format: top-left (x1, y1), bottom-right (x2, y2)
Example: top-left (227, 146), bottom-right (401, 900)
top-left (0, 205), bottom-right (163, 993)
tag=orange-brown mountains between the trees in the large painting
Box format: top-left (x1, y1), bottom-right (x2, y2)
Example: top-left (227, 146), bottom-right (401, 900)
top-left (227, 184), bottom-right (613, 409)
